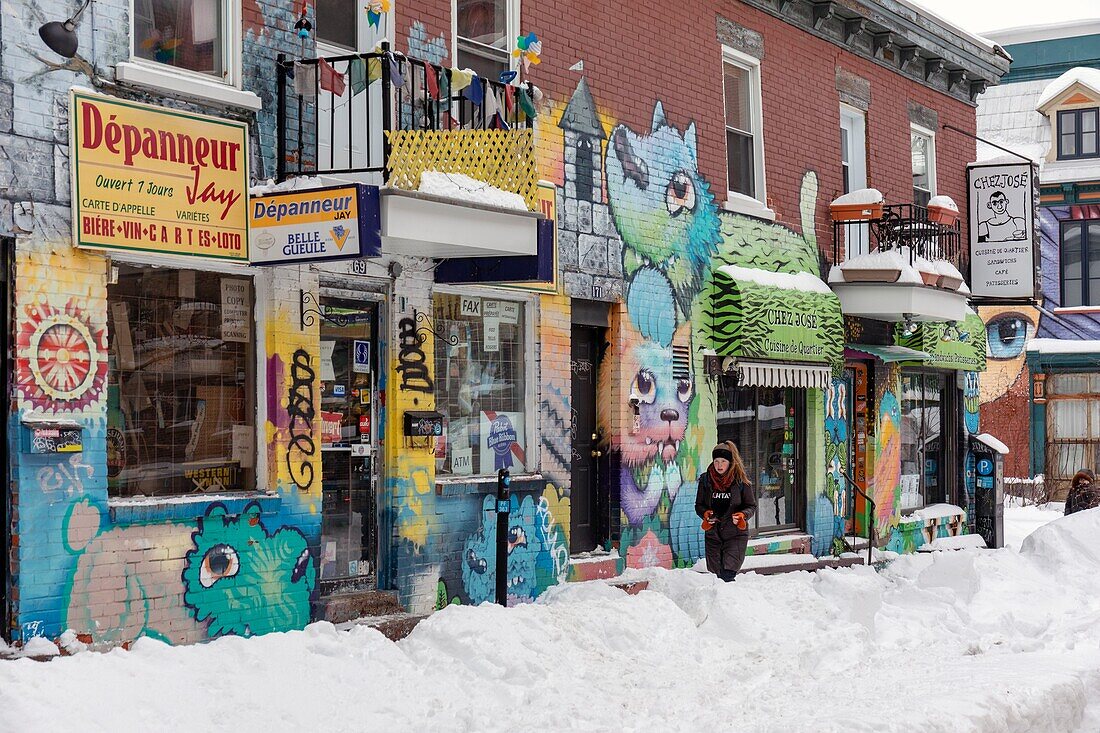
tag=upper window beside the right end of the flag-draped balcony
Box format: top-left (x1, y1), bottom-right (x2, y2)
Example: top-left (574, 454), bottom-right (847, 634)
top-left (453, 0), bottom-right (519, 81)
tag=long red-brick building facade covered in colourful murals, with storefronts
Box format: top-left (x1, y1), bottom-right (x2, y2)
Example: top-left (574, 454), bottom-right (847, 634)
top-left (0, 0), bottom-right (1007, 645)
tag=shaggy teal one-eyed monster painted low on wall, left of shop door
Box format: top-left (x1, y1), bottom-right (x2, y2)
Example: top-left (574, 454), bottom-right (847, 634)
top-left (183, 503), bottom-right (317, 636)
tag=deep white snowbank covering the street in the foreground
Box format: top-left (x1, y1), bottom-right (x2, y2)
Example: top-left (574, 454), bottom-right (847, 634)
top-left (0, 510), bottom-right (1100, 733)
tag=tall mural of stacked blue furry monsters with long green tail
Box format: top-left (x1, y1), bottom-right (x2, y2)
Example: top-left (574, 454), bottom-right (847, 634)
top-left (600, 96), bottom-right (827, 567)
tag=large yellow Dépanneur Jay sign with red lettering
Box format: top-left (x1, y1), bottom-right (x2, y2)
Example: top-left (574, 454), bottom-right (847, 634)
top-left (69, 90), bottom-right (249, 262)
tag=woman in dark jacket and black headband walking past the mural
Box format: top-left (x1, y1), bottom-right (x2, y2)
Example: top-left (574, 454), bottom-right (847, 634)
top-left (695, 440), bottom-right (756, 581)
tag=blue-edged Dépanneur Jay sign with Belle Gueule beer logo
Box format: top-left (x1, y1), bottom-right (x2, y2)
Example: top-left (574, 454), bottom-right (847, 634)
top-left (249, 184), bottom-right (382, 265)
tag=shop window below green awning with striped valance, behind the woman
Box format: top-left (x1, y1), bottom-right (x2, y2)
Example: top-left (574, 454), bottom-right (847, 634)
top-left (718, 378), bottom-right (802, 532)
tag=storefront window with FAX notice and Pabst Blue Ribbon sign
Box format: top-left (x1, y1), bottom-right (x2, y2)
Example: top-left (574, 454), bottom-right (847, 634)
top-left (435, 293), bottom-right (530, 477)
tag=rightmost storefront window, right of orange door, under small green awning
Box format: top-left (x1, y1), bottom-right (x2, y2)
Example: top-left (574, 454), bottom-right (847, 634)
top-left (901, 373), bottom-right (945, 512)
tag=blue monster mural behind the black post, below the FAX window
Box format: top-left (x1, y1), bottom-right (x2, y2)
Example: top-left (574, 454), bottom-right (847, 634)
top-left (462, 494), bottom-right (568, 604)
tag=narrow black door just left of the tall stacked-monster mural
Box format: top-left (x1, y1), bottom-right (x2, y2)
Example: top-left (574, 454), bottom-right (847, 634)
top-left (570, 325), bottom-right (602, 553)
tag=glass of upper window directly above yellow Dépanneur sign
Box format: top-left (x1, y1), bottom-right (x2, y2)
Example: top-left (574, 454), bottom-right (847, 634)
top-left (133, 0), bottom-right (234, 83)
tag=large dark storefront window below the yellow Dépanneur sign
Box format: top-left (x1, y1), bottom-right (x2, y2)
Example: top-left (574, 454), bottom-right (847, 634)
top-left (107, 265), bottom-right (255, 496)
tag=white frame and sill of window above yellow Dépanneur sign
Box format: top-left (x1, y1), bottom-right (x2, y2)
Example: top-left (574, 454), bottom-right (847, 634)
top-left (116, 0), bottom-right (263, 111)
